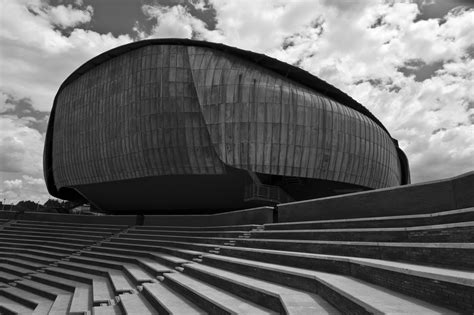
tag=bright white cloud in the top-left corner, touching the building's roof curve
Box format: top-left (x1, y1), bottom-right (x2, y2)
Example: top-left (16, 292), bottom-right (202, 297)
top-left (0, 0), bottom-right (132, 111)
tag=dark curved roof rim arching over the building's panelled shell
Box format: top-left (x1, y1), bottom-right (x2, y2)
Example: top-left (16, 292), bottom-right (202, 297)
top-left (55, 38), bottom-right (390, 135)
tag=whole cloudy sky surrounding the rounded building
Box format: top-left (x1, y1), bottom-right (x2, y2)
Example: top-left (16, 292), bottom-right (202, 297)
top-left (0, 0), bottom-right (474, 203)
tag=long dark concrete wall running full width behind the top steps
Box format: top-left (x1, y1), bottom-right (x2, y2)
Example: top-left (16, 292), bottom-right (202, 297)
top-left (0, 172), bottom-right (474, 226)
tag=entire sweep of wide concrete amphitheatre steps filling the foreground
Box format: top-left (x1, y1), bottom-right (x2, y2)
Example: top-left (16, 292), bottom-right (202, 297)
top-left (0, 208), bottom-right (474, 314)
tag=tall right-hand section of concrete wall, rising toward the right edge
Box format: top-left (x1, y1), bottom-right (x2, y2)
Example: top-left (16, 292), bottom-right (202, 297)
top-left (278, 172), bottom-right (474, 222)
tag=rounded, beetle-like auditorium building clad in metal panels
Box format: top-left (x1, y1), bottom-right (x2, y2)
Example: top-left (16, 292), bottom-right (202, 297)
top-left (44, 39), bottom-right (410, 214)
